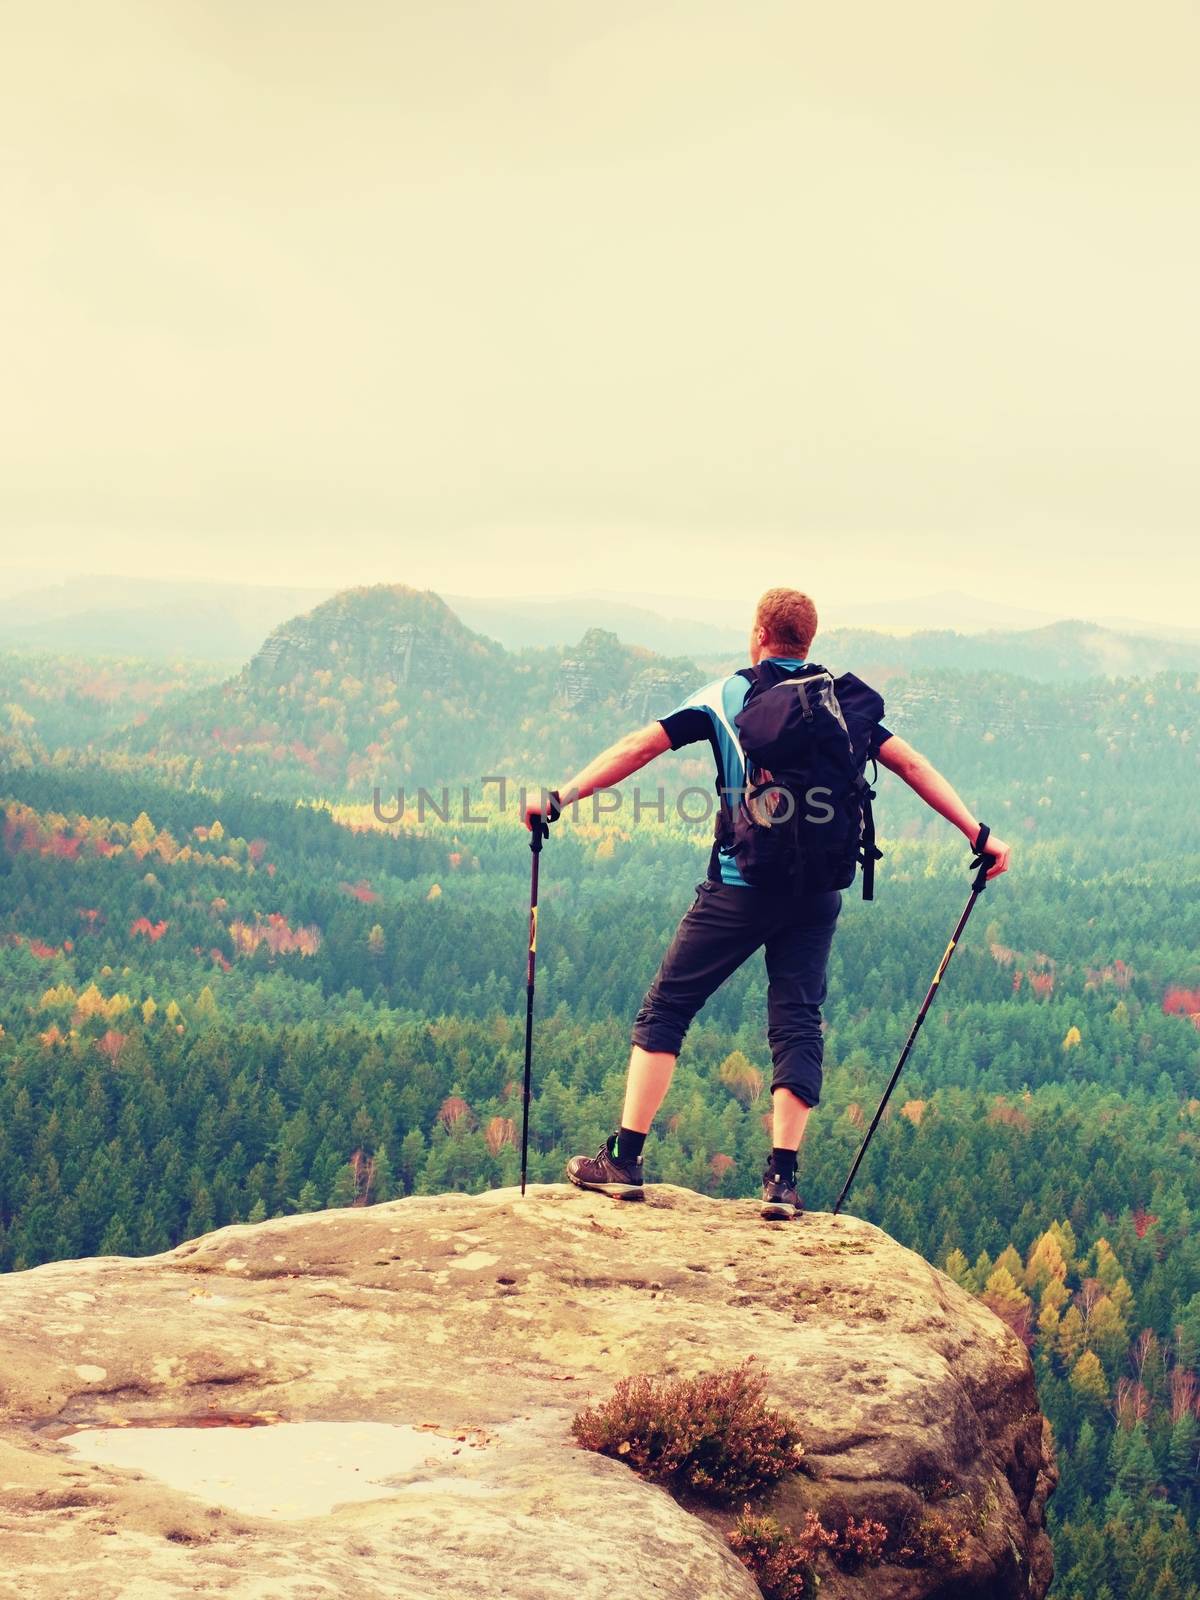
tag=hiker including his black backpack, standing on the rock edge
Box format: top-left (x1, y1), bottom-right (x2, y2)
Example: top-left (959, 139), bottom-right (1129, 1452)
top-left (523, 589), bottom-right (1010, 1218)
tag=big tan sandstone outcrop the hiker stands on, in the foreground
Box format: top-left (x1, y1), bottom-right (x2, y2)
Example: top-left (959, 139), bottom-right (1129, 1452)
top-left (0, 1184), bottom-right (1054, 1600)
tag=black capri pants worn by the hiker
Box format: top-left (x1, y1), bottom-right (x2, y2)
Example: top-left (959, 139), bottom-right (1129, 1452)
top-left (632, 878), bottom-right (842, 1106)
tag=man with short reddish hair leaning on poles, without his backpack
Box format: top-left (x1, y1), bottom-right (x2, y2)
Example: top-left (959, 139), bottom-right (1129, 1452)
top-left (523, 589), bottom-right (1010, 1218)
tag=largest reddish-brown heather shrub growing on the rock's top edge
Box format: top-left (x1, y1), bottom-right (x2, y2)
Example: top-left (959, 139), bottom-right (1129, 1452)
top-left (571, 1357), bottom-right (803, 1499)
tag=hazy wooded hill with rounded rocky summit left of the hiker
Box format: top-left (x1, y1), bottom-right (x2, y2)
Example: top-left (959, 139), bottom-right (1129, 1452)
top-left (110, 584), bottom-right (702, 800)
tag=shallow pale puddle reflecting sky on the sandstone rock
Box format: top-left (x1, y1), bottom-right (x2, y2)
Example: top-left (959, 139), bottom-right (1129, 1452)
top-left (55, 1411), bottom-right (491, 1518)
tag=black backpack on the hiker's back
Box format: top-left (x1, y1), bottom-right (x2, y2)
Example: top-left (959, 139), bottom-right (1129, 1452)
top-left (717, 661), bottom-right (883, 899)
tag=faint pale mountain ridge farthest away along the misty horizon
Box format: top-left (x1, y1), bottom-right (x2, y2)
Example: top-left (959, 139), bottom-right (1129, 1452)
top-left (0, 574), bottom-right (1200, 680)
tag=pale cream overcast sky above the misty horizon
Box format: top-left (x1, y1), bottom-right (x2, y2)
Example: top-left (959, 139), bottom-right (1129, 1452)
top-left (0, 0), bottom-right (1200, 624)
